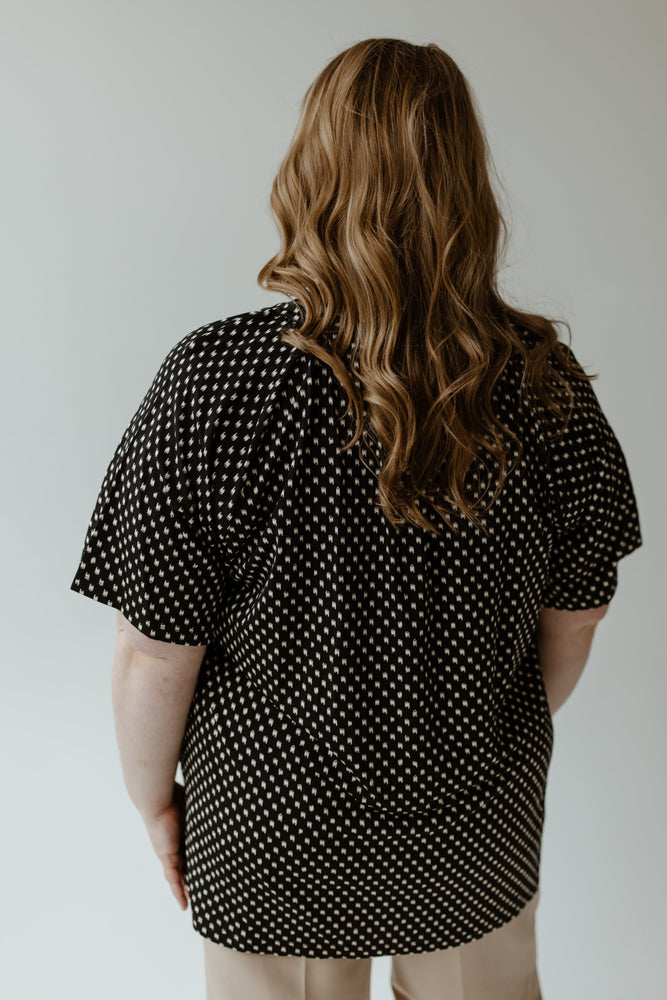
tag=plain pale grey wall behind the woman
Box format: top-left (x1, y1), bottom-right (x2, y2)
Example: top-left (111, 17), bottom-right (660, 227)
top-left (0, 0), bottom-right (667, 1000)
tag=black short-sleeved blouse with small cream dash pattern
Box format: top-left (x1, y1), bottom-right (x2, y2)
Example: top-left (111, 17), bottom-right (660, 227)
top-left (71, 300), bottom-right (642, 958)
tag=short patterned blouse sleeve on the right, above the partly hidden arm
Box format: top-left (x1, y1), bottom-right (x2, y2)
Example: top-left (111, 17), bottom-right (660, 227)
top-left (541, 347), bottom-right (642, 611)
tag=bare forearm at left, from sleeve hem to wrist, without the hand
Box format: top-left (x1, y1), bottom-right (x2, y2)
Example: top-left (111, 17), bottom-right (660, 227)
top-left (112, 641), bottom-right (198, 816)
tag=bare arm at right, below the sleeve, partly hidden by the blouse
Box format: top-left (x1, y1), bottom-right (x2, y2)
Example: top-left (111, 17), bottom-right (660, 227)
top-left (537, 604), bottom-right (609, 715)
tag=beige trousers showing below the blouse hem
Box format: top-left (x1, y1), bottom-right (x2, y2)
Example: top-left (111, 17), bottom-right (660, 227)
top-left (202, 890), bottom-right (542, 1000)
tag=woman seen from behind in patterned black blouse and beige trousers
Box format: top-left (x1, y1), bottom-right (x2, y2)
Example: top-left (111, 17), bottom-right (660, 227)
top-left (71, 39), bottom-right (642, 1000)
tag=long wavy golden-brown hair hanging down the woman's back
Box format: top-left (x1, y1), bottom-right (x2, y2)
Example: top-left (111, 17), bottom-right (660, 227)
top-left (257, 38), bottom-right (597, 534)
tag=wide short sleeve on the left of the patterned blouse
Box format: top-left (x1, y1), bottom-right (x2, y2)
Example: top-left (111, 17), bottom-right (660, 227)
top-left (70, 334), bottom-right (224, 646)
